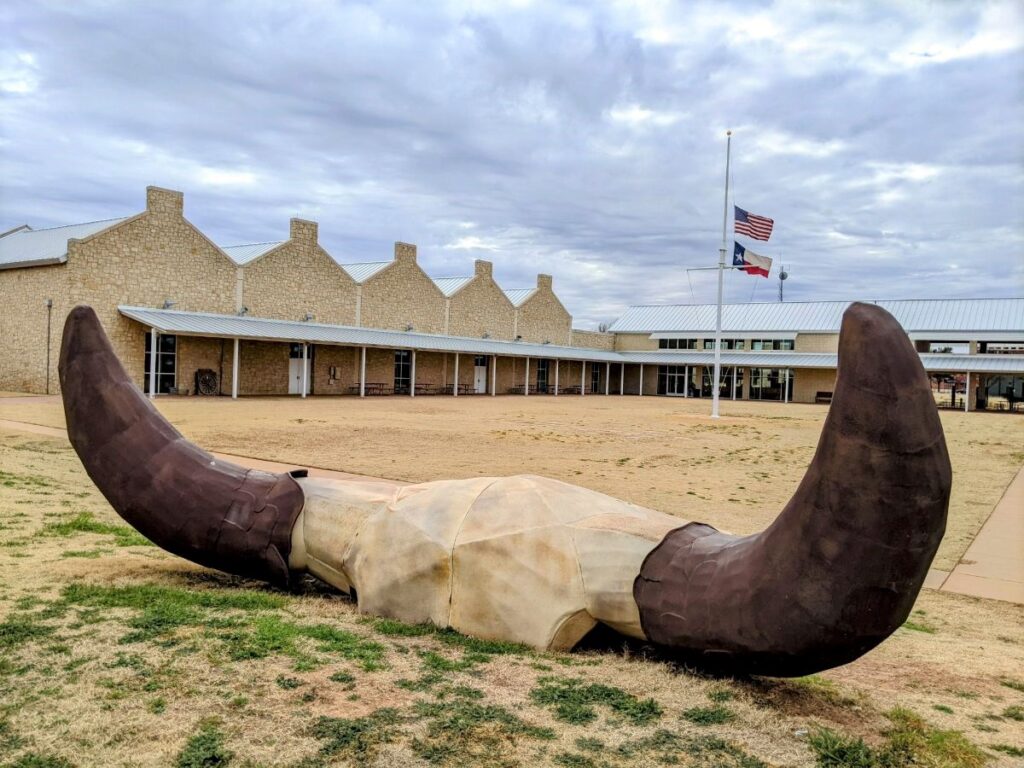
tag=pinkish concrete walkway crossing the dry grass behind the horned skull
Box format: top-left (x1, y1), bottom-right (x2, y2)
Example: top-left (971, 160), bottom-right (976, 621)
top-left (0, 419), bottom-right (1024, 604)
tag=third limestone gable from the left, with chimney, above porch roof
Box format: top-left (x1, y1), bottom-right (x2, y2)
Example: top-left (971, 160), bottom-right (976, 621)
top-left (360, 243), bottom-right (444, 334)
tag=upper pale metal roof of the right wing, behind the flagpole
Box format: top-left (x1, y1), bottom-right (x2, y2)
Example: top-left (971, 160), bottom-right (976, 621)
top-left (609, 299), bottom-right (1024, 336)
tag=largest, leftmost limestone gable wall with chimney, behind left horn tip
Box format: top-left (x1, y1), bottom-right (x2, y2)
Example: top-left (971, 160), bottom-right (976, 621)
top-left (64, 186), bottom-right (236, 391)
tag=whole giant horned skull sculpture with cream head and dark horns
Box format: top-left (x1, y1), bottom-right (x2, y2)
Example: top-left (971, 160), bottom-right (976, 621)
top-left (60, 304), bottom-right (950, 675)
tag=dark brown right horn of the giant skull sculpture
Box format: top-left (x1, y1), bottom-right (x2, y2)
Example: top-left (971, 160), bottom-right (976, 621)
top-left (633, 304), bottom-right (951, 676)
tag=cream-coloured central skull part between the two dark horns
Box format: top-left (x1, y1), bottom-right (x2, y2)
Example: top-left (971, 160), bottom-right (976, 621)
top-left (289, 475), bottom-right (687, 649)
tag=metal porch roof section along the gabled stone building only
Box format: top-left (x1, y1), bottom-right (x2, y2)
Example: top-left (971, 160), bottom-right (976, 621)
top-left (118, 306), bottom-right (622, 362)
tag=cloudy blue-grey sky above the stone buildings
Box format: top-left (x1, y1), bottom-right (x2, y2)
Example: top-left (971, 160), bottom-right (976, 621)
top-left (0, 0), bottom-right (1024, 328)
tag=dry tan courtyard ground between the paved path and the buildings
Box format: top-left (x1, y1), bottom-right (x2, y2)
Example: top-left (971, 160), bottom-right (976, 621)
top-left (0, 395), bottom-right (1024, 570)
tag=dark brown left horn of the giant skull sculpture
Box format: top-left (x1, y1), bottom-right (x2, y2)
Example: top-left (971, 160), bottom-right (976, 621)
top-left (59, 306), bottom-right (303, 584)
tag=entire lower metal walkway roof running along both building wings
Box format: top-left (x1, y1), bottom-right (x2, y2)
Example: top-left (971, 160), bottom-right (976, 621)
top-left (118, 306), bottom-right (1024, 374)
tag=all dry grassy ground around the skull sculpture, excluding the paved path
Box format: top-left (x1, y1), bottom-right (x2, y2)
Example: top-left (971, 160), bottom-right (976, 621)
top-left (0, 396), bottom-right (1024, 768)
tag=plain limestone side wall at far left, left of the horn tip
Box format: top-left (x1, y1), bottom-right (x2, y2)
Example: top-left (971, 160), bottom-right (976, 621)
top-left (0, 264), bottom-right (71, 393)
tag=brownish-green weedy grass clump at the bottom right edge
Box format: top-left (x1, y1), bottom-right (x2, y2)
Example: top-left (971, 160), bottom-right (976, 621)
top-left (809, 708), bottom-right (987, 768)
